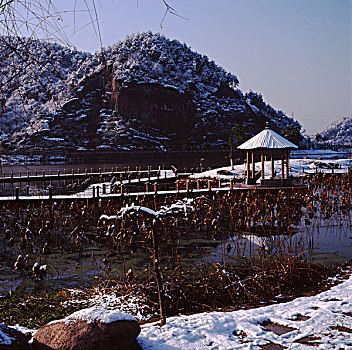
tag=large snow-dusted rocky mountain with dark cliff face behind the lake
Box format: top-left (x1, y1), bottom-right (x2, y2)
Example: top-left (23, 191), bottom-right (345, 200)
top-left (0, 32), bottom-right (301, 150)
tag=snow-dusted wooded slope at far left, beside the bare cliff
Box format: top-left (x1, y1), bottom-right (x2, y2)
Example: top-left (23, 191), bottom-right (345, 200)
top-left (0, 37), bottom-right (91, 140)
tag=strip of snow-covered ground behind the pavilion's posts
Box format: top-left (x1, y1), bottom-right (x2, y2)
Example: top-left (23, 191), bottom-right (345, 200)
top-left (191, 158), bottom-right (352, 181)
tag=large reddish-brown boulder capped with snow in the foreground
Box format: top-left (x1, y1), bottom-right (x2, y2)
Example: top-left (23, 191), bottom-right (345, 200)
top-left (33, 307), bottom-right (140, 350)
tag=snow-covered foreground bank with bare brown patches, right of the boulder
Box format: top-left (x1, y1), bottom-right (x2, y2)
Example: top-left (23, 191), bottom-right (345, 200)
top-left (138, 276), bottom-right (352, 350)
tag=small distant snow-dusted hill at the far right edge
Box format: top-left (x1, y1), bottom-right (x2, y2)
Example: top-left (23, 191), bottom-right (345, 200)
top-left (315, 115), bottom-right (352, 147)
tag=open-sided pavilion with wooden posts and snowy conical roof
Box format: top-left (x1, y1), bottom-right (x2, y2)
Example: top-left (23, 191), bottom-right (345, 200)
top-left (237, 123), bottom-right (298, 184)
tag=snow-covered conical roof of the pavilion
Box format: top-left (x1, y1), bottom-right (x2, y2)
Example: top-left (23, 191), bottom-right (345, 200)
top-left (237, 127), bottom-right (298, 149)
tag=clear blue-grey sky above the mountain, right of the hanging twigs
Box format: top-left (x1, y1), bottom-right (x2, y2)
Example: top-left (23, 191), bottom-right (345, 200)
top-left (56, 0), bottom-right (352, 133)
